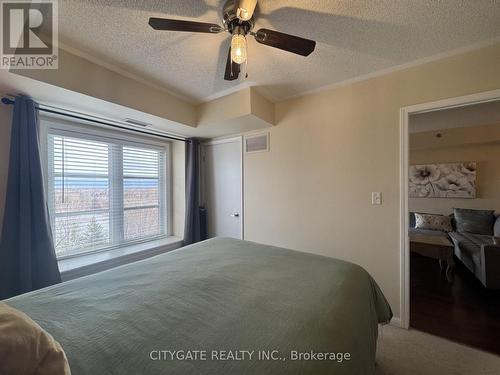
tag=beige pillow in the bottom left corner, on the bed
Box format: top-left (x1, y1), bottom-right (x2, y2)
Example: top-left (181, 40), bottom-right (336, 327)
top-left (0, 302), bottom-right (71, 375)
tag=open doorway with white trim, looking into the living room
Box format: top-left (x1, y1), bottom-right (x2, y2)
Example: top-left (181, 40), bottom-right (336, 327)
top-left (401, 90), bottom-right (500, 354)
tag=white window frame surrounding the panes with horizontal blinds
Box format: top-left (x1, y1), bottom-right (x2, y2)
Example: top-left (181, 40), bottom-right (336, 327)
top-left (39, 114), bottom-right (173, 260)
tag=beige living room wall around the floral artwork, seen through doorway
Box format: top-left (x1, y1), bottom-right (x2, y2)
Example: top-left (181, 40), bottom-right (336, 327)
top-left (409, 125), bottom-right (500, 215)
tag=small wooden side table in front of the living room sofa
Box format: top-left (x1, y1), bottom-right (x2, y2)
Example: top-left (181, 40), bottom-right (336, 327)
top-left (410, 233), bottom-right (455, 282)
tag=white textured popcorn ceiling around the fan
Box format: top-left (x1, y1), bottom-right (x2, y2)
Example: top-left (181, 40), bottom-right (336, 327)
top-left (53, 0), bottom-right (500, 101)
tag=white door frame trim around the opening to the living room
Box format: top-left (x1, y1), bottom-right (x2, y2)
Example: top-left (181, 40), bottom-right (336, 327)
top-left (396, 89), bottom-right (500, 329)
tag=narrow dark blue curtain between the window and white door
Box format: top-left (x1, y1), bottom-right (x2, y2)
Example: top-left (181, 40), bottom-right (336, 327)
top-left (184, 138), bottom-right (204, 245)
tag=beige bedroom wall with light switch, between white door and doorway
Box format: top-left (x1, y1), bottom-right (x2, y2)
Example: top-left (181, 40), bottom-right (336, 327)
top-left (244, 45), bottom-right (500, 316)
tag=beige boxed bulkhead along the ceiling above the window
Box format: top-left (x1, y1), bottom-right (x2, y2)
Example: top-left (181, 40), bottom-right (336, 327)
top-left (8, 46), bottom-right (275, 138)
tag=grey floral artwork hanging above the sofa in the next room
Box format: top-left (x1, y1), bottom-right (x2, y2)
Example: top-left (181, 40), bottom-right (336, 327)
top-left (409, 162), bottom-right (476, 198)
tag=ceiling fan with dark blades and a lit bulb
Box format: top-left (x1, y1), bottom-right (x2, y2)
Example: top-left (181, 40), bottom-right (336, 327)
top-left (149, 0), bottom-right (316, 81)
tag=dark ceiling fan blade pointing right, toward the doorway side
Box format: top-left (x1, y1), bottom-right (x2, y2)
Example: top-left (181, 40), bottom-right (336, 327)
top-left (254, 29), bottom-right (316, 56)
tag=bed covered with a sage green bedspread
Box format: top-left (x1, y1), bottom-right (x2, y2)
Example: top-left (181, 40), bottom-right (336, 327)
top-left (4, 238), bottom-right (392, 375)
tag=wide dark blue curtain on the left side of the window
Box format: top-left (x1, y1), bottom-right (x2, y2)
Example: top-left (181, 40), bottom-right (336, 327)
top-left (0, 96), bottom-right (61, 299)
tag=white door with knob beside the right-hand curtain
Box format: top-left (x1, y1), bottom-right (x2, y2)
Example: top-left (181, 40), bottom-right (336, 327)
top-left (203, 137), bottom-right (243, 239)
